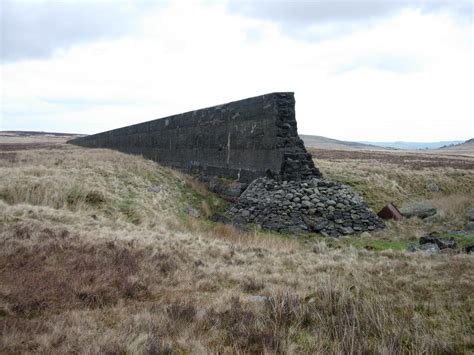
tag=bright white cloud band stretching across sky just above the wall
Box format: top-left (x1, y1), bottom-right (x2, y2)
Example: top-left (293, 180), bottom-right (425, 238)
top-left (1, 2), bottom-right (474, 140)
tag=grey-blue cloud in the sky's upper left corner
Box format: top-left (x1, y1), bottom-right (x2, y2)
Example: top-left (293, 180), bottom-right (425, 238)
top-left (0, 0), bottom-right (161, 62)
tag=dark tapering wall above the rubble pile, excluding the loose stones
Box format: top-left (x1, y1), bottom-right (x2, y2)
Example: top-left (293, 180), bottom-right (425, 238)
top-left (69, 93), bottom-right (320, 182)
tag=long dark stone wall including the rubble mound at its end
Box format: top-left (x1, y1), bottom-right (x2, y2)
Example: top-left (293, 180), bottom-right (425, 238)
top-left (69, 92), bottom-right (384, 237)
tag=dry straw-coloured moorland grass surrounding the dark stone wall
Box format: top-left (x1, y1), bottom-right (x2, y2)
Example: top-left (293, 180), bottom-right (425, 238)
top-left (0, 138), bottom-right (474, 354)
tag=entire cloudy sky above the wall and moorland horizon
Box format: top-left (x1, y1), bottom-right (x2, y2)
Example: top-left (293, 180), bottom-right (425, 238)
top-left (0, 0), bottom-right (474, 142)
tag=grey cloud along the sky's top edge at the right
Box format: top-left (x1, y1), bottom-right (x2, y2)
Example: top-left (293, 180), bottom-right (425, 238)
top-left (227, 0), bottom-right (474, 41)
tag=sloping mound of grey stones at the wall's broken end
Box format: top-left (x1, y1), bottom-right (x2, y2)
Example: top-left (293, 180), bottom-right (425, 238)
top-left (227, 177), bottom-right (385, 237)
